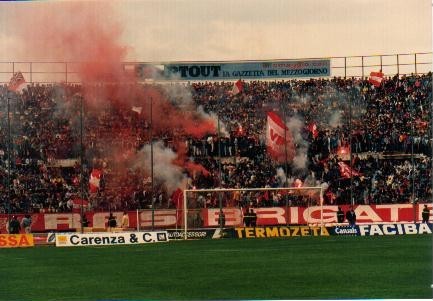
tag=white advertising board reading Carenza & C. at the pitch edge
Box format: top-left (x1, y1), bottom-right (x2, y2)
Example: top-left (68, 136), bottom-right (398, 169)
top-left (56, 231), bottom-right (169, 247)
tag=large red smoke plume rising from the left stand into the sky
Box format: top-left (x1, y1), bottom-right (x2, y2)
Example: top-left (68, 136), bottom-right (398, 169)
top-left (13, 1), bottom-right (215, 190)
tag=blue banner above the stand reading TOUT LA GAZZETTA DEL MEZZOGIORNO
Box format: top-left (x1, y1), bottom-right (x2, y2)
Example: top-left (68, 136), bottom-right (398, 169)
top-left (135, 59), bottom-right (331, 80)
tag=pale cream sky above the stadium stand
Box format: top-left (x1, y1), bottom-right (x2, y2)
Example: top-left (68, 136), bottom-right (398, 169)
top-left (0, 0), bottom-right (432, 61)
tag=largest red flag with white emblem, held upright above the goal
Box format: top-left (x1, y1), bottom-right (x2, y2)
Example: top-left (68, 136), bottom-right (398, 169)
top-left (266, 112), bottom-right (295, 162)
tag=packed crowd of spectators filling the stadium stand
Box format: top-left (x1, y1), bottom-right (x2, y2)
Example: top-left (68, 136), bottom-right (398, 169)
top-left (0, 73), bottom-right (432, 212)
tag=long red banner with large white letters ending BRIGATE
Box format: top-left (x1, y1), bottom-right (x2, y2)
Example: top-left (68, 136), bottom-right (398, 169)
top-left (0, 204), bottom-right (433, 233)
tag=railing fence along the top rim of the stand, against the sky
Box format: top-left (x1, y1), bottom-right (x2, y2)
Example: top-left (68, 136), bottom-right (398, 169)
top-left (0, 52), bottom-right (432, 84)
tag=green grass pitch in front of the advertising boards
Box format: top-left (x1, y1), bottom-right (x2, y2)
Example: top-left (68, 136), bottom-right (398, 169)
top-left (0, 235), bottom-right (432, 301)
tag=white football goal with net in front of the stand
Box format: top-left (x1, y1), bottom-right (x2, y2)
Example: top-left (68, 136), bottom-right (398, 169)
top-left (179, 187), bottom-right (323, 237)
